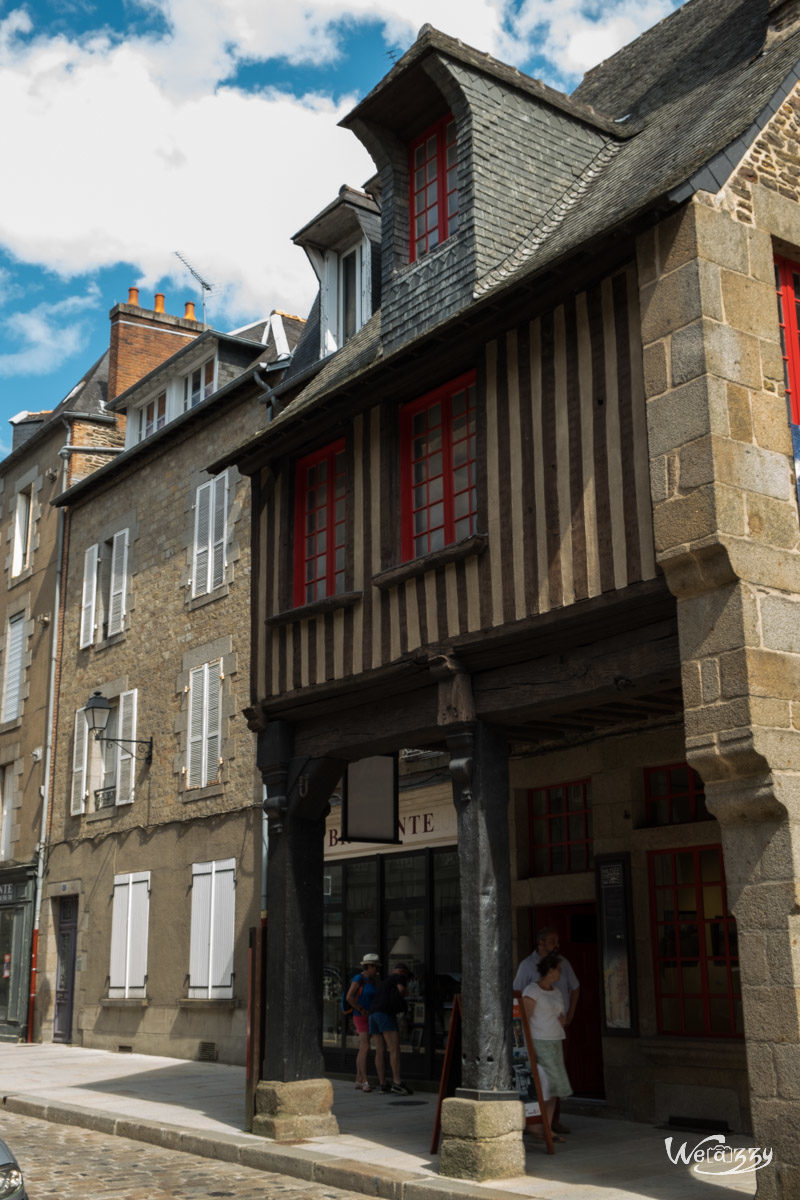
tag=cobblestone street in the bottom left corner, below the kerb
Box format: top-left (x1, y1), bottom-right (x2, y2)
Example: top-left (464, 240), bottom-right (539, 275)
top-left (0, 1112), bottom-right (367, 1200)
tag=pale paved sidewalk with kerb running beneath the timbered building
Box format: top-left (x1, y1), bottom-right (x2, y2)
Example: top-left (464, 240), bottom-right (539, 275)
top-left (0, 1043), bottom-right (770, 1200)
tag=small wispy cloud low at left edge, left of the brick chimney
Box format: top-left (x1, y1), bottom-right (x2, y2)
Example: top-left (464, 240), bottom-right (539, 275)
top-left (0, 284), bottom-right (100, 374)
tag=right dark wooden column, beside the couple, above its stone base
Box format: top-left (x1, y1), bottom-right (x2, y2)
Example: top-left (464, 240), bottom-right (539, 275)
top-left (447, 721), bottom-right (517, 1100)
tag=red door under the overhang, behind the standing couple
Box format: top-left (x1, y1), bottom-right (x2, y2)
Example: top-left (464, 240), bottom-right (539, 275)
top-left (530, 904), bottom-right (606, 1098)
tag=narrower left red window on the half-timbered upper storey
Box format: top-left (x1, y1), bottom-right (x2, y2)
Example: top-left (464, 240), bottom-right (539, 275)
top-left (294, 438), bottom-right (347, 605)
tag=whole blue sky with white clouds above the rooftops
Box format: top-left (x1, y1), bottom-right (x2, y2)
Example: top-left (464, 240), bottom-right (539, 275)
top-left (0, 0), bottom-right (679, 455)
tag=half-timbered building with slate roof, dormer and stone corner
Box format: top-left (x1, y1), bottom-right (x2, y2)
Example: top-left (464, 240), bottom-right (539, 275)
top-left (215, 0), bottom-right (800, 1200)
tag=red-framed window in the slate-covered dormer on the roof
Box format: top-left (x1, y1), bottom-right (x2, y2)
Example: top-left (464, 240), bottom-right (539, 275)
top-left (409, 114), bottom-right (458, 262)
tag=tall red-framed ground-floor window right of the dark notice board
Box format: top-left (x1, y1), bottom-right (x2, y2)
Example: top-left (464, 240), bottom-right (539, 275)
top-left (649, 846), bottom-right (744, 1037)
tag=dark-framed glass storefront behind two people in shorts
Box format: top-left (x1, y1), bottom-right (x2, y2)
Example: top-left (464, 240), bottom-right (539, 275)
top-left (323, 846), bottom-right (461, 1079)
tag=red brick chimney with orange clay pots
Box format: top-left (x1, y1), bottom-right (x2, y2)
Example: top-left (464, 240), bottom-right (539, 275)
top-left (108, 288), bottom-right (205, 400)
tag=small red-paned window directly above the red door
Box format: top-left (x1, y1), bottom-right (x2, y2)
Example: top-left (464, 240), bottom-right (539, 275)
top-left (528, 779), bottom-right (593, 875)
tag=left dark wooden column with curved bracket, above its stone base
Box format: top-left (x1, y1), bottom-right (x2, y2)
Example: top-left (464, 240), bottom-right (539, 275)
top-left (258, 721), bottom-right (343, 1082)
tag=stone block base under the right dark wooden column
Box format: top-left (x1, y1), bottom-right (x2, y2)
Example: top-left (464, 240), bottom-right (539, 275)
top-left (439, 1097), bottom-right (525, 1181)
